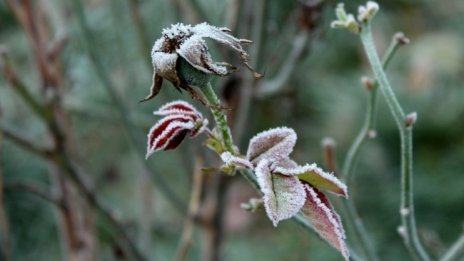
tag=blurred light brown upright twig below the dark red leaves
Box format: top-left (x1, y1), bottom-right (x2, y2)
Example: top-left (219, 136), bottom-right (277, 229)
top-left (176, 157), bottom-right (203, 261)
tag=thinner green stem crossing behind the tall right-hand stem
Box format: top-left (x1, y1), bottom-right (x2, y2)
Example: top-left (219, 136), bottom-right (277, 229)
top-left (342, 33), bottom-right (400, 260)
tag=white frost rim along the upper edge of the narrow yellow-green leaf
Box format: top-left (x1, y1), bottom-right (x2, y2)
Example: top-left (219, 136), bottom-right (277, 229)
top-left (274, 163), bottom-right (348, 197)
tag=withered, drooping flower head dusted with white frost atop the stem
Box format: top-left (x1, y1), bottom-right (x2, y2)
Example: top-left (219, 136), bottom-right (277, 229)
top-left (142, 23), bottom-right (261, 101)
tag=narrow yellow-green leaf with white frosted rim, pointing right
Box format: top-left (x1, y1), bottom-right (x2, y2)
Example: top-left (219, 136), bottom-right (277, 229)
top-left (274, 163), bottom-right (348, 197)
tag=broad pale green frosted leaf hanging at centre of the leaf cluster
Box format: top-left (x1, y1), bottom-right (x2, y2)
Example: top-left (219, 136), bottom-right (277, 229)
top-left (255, 159), bottom-right (306, 226)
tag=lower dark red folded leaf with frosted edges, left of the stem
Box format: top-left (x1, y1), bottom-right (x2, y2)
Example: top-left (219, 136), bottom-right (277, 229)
top-left (146, 115), bottom-right (194, 158)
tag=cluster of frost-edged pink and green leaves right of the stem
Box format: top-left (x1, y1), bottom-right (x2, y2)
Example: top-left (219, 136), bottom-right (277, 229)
top-left (221, 127), bottom-right (349, 259)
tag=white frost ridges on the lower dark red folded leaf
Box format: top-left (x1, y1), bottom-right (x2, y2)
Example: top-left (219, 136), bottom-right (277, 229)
top-left (145, 115), bottom-right (194, 159)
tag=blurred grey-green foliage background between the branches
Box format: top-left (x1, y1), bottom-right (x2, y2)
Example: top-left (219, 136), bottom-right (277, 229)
top-left (0, 0), bottom-right (464, 260)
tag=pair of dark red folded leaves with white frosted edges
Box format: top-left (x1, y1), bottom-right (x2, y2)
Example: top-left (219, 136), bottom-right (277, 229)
top-left (146, 101), bottom-right (208, 158)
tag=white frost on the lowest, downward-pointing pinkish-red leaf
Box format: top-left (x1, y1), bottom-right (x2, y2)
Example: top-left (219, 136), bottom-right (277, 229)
top-left (305, 185), bottom-right (350, 260)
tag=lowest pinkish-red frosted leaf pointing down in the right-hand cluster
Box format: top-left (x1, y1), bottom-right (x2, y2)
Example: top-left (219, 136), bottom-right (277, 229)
top-left (301, 185), bottom-right (350, 260)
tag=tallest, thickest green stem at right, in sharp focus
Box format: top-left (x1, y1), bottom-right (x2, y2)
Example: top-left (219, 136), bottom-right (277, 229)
top-left (360, 22), bottom-right (430, 260)
